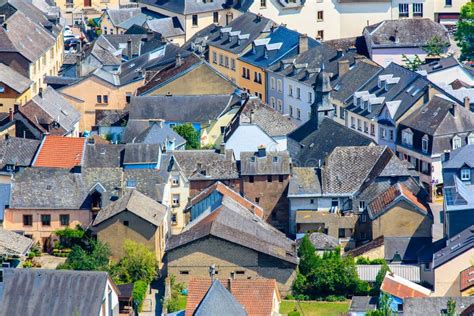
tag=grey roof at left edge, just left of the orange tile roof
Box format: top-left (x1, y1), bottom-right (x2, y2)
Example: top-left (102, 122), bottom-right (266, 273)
top-left (0, 137), bottom-right (41, 168)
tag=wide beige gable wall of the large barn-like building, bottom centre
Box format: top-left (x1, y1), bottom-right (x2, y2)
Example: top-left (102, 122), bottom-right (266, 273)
top-left (166, 237), bottom-right (296, 295)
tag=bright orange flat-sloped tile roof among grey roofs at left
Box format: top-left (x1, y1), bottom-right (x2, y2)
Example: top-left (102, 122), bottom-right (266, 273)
top-left (33, 135), bottom-right (85, 169)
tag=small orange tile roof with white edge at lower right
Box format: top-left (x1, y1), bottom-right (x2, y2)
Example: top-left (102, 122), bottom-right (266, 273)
top-left (380, 273), bottom-right (431, 299)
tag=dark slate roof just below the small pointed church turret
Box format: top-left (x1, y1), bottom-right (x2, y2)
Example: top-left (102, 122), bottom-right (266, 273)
top-left (288, 118), bottom-right (374, 167)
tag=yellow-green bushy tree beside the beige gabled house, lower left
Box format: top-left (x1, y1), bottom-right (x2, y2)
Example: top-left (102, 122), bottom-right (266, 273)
top-left (111, 240), bottom-right (158, 284)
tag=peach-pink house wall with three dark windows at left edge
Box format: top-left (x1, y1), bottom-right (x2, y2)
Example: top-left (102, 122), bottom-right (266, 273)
top-left (3, 209), bottom-right (92, 244)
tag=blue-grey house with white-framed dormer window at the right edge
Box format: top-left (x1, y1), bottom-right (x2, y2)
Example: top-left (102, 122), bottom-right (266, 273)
top-left (442, 144), bottom-right (474, 238)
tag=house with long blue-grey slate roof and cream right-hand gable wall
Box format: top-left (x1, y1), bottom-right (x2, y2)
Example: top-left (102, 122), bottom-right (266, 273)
top-left (128, 94), bottom-right (242, 145)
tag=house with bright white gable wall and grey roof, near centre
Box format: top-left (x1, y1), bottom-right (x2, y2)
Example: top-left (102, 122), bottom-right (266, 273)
top-left (223, 97), bottom-right (297, 160)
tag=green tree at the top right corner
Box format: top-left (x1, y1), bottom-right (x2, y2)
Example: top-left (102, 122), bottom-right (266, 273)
top-left (454, 1), bottom-right (474, 61)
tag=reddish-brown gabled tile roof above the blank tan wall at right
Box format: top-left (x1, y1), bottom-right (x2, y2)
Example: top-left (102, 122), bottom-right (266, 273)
top-left (368, 183), bottom-right (429, 219)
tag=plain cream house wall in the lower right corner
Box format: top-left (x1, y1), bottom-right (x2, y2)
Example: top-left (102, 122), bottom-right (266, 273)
top-left (432, 248), bottom-right (474, 296)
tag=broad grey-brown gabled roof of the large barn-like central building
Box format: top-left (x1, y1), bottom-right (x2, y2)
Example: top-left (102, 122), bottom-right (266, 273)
top-left (167, 195), bottom-right (298, 265)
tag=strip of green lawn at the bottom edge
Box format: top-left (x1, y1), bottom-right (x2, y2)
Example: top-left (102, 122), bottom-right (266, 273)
top-left (280, 300), bottom-right (349, 316)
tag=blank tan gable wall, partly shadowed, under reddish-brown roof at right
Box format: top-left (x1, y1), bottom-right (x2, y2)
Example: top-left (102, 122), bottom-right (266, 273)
top-left (372, 201), bottom-right (433, 239)
